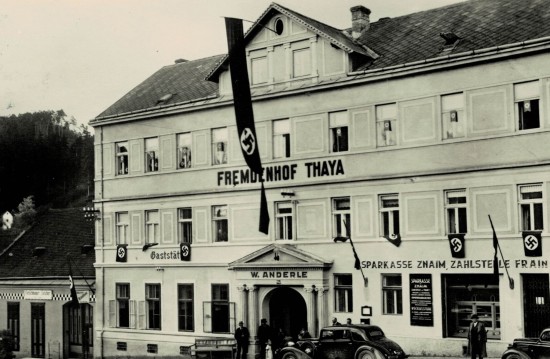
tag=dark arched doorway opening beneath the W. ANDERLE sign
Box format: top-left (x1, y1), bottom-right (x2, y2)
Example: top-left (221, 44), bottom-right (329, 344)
top-left (267, 287), bottom-right (313, 338)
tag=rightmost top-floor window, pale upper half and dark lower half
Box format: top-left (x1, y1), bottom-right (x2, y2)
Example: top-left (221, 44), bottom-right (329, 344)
top-left (514, 81), bottom-right (540, 130)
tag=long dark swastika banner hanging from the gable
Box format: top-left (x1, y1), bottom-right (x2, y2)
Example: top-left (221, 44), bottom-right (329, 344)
top-left (225, 18), bottom-right (269, 234)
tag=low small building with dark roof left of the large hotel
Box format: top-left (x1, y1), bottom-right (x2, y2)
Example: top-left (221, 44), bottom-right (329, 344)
top-left (0, 208), bottom-right (95, 359)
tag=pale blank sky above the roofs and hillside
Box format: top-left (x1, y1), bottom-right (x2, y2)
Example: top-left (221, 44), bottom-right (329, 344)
top-left (0, 0), bottom-right (461, 129)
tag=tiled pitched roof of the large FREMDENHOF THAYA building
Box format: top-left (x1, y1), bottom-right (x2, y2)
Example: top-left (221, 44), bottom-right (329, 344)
top-left (95, 0), bottom-right (550, 120)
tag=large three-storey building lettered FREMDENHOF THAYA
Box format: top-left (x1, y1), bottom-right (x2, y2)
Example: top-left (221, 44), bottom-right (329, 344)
top-left (90, 0), bottom-right (550, 358)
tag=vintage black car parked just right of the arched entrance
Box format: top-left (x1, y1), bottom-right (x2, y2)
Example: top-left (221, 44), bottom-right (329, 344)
top-left (277, 324), bottom-right (408, 359)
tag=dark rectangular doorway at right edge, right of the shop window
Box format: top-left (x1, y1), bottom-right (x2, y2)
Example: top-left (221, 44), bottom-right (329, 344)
top-left (523, 274), bottom-right (550, 337)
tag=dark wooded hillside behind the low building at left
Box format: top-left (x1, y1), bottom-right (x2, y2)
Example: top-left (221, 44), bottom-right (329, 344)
top-left (0, 110), bottom-right (94, 211)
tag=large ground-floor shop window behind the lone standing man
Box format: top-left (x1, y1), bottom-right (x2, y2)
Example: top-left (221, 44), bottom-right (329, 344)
top-left (443, 274), bottom-right (501, 339)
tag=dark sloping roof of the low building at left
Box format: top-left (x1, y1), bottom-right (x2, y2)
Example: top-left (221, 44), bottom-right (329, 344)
top-left (0, 208), bottom-right (95, 278)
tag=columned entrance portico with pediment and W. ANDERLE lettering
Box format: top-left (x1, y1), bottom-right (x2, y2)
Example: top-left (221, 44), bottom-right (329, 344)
top-left (229, 244), bottom-right (332, 352)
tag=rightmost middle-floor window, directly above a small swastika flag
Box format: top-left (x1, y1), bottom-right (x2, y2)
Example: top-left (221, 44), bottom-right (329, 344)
top-left (519, 184), bottom-right (544, 231)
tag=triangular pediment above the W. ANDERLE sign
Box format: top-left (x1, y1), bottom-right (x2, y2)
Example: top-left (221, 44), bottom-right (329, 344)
top-left (229, 244), bottom-right (333, 270)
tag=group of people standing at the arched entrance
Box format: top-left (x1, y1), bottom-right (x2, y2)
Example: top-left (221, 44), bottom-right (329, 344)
top-left (235, 318), bottom-right (311, 359)
